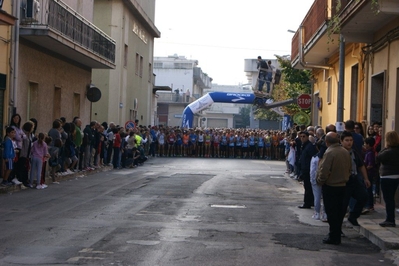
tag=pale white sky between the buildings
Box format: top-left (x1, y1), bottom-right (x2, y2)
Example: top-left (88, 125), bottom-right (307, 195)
top-left (154, 0), bottom-right (314, 85)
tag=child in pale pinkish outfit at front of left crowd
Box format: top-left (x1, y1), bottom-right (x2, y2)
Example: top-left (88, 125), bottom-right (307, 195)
top-left (29, 133), bottom-right (50, 189)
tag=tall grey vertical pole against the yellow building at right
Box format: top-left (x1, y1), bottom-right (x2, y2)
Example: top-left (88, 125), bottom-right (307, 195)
top-left (337, 34), bottom-right (345, 122)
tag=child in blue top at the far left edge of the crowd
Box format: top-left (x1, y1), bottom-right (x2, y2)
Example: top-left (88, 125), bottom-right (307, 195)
top-left (1, 127), bottom-right (16, 186)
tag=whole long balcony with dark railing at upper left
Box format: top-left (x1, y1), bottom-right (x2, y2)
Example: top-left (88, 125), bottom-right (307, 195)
top-left (20, 0), bottom-right (115, 69)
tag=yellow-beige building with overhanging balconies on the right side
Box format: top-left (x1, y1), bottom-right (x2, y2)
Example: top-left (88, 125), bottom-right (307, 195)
top-left (291, 0), bottom-right (399, 131)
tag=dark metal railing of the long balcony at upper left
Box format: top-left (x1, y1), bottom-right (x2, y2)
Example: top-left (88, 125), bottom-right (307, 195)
top-left (20, 0), bottom-right (116, 63)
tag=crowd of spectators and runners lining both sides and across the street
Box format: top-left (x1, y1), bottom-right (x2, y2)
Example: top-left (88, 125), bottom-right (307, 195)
top-left (2, 112), bottom-right (394, 237)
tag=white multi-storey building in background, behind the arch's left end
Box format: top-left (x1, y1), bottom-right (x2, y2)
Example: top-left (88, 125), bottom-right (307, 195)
top-left (154, 55), bottom-right (212, 127)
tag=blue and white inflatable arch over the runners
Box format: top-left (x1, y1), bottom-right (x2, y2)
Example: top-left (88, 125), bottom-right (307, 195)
top-left (181, 92), bottom-right (255, 128)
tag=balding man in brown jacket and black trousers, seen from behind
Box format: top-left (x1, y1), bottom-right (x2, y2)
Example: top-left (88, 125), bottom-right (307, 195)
top-left (317, 132), bottom-right (352, 245)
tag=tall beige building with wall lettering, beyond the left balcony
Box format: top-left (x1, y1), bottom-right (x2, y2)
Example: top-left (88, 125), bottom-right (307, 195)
top-left (92, 0), bottom-right (160, 128)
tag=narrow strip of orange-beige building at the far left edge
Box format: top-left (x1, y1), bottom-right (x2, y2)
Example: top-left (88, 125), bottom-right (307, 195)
top-left (0, 1), bottom-right (15, 132)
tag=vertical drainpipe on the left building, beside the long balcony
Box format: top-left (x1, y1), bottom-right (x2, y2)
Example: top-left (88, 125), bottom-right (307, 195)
top-left (8, 0), bottom-right (21, 116)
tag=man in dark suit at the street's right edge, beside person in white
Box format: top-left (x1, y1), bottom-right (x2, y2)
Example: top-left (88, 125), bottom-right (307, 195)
top-left (298, 131), bottom-right (317, 209)
